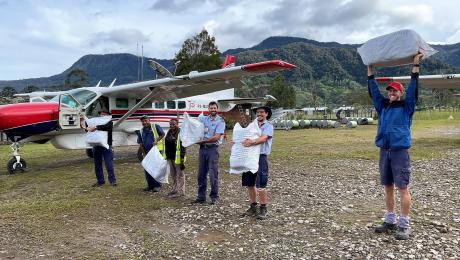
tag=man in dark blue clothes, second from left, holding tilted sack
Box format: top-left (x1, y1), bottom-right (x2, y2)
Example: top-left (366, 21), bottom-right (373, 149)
top-left (137, 115), bottom-right (165, 192)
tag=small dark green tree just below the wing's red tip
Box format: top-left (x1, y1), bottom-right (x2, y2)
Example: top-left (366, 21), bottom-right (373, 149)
top-left (269, 75), bottom-right (296, 108)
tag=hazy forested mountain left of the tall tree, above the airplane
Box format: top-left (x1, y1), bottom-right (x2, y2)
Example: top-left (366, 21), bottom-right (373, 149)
top-left (0, 53), bottom-right (174, 90)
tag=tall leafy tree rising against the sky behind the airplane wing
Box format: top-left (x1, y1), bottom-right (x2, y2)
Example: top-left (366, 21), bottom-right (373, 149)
top-left (174, 29), bottom-right (222, 75)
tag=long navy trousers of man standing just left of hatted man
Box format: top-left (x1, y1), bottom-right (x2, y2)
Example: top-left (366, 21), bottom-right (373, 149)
top-left (197, 146), bottom-right (219, 200)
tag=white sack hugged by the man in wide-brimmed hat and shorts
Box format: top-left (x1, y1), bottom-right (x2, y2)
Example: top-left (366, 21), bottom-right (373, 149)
top-left (230, 119), bottom-right (262, 174)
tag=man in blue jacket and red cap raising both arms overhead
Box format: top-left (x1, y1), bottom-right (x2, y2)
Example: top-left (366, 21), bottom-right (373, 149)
top-left (367, 54), bottom-right (423, 240)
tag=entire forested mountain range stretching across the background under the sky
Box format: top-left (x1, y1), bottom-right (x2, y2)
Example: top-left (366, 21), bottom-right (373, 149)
top-left (0, 36), bottom-right (460, 91)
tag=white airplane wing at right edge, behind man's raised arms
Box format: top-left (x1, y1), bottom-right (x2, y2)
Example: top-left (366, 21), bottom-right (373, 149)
top-left (375, 74), bottom-right (460, 89)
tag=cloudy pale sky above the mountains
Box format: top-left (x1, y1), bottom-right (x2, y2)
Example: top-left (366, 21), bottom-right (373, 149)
top-left (0, 0), bottom-right (460, 80)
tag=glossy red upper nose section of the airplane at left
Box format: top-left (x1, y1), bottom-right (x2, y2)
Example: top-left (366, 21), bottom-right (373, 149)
top-left (0, 102), bottom-right (59, 130)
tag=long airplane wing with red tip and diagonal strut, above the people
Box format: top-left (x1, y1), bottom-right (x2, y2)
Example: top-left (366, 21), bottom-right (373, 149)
top-left (112, 60), bottom-right (296, 127)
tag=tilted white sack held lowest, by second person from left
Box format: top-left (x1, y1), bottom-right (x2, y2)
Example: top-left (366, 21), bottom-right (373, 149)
top-left (142, 146), bottom-right (169, 183)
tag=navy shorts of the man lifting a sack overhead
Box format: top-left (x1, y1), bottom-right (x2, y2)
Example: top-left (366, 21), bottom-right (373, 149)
top-left (379, 149), bottom-right (411, 189)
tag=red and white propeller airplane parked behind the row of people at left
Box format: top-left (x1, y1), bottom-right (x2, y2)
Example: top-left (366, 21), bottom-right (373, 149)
top-left (0, 55), bottom-right (296, 174)
